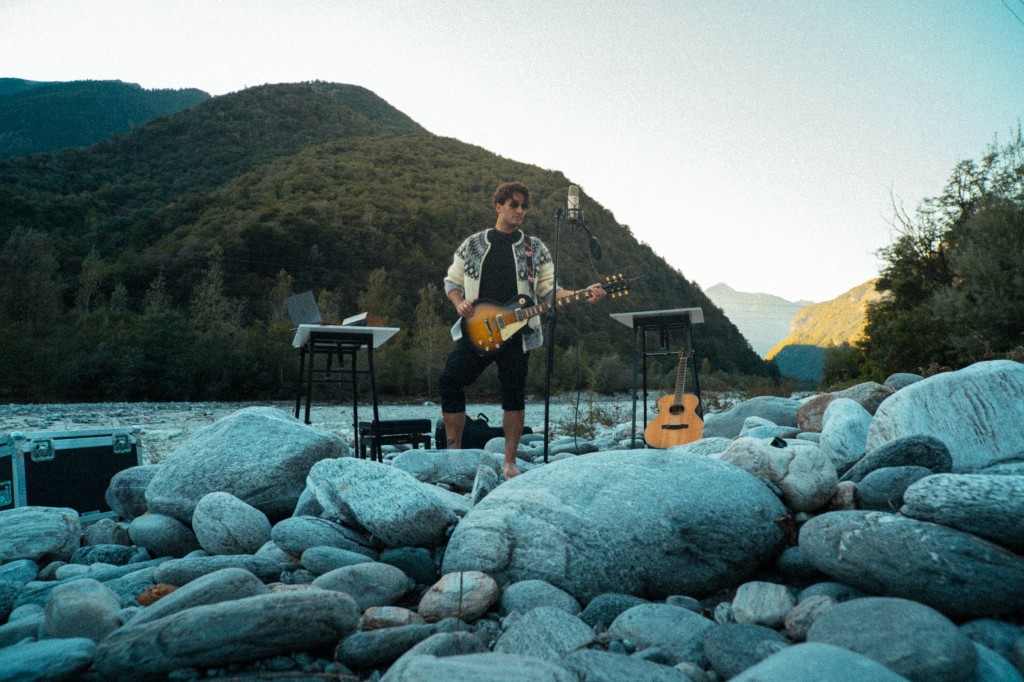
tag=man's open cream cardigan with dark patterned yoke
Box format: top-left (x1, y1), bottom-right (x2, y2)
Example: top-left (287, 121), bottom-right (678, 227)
top-left (444, 230), bottom-right (555, 351)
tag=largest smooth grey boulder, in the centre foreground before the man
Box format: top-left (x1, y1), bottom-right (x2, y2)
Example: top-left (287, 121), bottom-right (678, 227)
top-left (442, 450), bottom-right (785, 602)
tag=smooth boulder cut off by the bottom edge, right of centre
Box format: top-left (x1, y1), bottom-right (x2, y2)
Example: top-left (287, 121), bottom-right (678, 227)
top-left (731, 642), bottom-right (907, 682)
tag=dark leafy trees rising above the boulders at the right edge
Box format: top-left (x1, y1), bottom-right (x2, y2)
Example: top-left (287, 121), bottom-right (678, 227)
top-left (825, 123), bottom-right (1024, 384)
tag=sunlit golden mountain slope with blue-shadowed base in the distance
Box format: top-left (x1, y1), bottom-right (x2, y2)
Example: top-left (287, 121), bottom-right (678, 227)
top-left (766, 280), bottom-right (880, 382)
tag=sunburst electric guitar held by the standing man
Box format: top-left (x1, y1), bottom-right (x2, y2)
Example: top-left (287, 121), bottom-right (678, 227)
top-left (462, 274), bottom-right (629, 356)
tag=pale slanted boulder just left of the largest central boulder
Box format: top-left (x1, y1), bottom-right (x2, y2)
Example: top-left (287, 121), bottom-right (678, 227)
top-left (308, 459), bottom-right (459, 547)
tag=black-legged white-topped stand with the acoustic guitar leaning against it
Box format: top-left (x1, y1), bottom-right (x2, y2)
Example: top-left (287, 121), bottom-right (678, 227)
top-left (610, 308), bottom-right (703, 446)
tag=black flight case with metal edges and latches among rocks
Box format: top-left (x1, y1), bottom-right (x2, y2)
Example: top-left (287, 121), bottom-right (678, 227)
top-left (0, 427), bottom-right (142, 517)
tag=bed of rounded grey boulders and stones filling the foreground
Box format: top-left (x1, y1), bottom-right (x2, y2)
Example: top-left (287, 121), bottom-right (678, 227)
top-left (0, 360), bottom-right (1024, 682)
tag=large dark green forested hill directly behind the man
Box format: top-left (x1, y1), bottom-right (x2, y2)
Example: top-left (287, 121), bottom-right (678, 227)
top-left (0, 83), bottom-right (774, 400)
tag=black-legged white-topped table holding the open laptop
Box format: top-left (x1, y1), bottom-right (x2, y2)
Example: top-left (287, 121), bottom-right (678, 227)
top-left (292, 325), bottom-right (398, 461)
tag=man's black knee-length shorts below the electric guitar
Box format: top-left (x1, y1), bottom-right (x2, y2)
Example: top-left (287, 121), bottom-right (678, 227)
top-left (439, 336), bottom-right (529, 413)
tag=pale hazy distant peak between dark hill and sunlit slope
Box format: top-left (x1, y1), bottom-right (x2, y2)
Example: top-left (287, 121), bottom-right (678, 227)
top-left (705, 283), bottom-right (811, 357)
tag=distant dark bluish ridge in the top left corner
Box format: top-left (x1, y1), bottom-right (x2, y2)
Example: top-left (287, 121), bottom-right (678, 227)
top-left (0, 78), bottom-right (210, 159)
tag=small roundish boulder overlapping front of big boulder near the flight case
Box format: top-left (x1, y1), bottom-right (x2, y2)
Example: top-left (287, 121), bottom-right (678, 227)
top-left (191, 493), bottom-right (270, 554)
